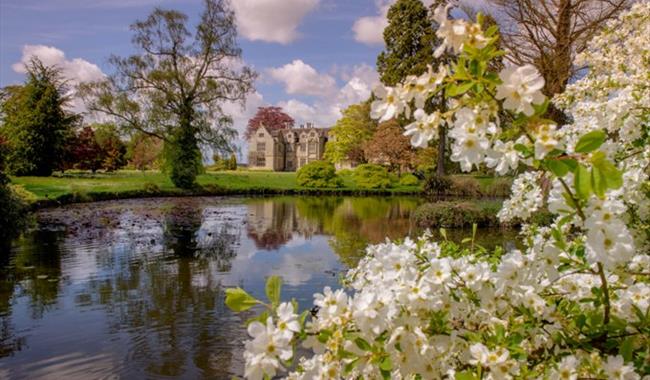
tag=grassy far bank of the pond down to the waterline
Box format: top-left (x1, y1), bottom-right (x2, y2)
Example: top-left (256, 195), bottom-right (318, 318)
top-left (12, 171), bottom-right (422, 209)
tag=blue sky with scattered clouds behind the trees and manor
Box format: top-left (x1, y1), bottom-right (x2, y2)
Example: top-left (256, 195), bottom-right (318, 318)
top-left (0, 0), bottom-right (410, 154)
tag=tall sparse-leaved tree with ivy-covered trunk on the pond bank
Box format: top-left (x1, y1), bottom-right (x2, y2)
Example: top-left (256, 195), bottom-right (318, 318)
top-left (81, 0), bottom-right (256, 188)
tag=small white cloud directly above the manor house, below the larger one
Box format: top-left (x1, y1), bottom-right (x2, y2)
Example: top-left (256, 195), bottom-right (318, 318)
top-left (268, 59), bottom-right (336, 97)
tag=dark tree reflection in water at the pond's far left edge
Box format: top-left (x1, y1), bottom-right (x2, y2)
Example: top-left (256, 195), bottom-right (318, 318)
top-left (0, 230), bottom-right (62, 357)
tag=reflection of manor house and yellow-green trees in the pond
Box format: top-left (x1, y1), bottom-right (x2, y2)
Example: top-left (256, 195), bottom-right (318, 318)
top-left (248, 197), bottom-right (418, 265)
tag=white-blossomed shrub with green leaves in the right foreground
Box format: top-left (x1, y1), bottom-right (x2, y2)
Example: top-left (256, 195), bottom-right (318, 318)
top-left (227, 2), bottom-right (650, 379)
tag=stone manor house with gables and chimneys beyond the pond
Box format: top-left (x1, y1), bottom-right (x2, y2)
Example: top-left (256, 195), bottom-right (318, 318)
top-left (248, 123), bottom-right (329, 171)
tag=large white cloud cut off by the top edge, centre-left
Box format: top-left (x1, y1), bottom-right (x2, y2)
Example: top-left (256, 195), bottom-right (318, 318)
top-left (232, 0), bottom-right (319, 44)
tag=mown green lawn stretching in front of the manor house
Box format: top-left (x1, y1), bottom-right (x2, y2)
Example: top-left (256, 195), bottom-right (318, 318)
top-left (11, 170), bottom-right (419, 205)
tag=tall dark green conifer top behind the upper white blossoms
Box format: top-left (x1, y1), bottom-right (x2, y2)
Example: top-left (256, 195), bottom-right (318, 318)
top-left (377, 0), bottom-right (437, 86)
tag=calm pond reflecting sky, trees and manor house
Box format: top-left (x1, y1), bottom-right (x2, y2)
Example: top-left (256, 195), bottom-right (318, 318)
top-left (0, 197), bottom-right (513, 379)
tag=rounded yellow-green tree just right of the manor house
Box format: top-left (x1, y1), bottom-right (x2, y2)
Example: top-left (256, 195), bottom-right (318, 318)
top-left (325, 102), bottom-right (377, 163)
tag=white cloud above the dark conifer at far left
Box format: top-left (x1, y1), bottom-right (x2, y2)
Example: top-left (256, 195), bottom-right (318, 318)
top-left (11, 45), bottom-right (105, 113)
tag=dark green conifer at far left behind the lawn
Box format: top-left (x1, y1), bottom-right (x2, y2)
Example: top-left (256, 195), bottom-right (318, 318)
top-left (0, 59), bottom-right (79, 176)
